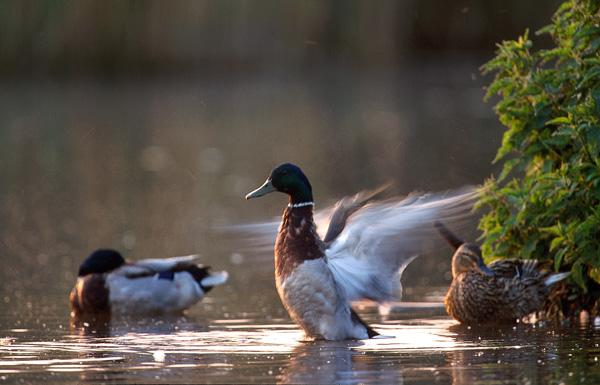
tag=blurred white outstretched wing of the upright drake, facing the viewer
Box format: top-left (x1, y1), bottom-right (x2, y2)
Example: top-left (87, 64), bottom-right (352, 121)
top-left (326, 187), bottom-right (477, 302)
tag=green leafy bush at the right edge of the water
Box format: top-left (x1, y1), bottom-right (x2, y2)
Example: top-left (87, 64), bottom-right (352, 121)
top-left (479, 0), bottom-right (600, 315)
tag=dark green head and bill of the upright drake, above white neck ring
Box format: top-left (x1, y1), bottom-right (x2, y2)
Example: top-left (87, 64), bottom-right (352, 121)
top-left (246, 163), bottom-right (313, 204)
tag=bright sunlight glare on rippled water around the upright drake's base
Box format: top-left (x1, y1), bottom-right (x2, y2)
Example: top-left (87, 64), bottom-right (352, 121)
top-left (0, 320), bottom-right (510, 371)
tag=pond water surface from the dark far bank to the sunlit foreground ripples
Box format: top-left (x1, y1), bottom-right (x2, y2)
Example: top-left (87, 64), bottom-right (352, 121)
top-left (0, 64), bottom-right (600, 384)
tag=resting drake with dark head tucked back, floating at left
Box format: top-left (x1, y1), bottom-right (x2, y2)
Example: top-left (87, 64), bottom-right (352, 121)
top-left (70, 249), bottom-right (228, 314)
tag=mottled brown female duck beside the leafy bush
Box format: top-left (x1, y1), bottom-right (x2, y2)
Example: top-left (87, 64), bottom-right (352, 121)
top-left (435, 223), bottom-right (569, 325)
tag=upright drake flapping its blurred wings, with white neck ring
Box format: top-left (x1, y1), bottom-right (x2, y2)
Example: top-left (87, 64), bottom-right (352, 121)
top-left (246, 163), bottom-right (473, 340)
